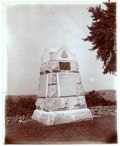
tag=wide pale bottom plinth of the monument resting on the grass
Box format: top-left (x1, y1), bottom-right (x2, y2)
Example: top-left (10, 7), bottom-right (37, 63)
top-left (32, 108), bottom-right (93, 125)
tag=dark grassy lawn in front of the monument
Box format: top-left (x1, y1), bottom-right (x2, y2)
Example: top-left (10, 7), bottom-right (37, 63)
top-left (5, 115), bottom-right (117, 144)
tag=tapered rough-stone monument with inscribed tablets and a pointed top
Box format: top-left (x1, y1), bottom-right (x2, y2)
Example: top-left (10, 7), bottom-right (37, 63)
top-left (32, 46), bottom-right (93, 125)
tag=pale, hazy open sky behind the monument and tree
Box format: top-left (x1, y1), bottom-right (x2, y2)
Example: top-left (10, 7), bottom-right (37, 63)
top-left (3, 2), bottom-right (117, 95)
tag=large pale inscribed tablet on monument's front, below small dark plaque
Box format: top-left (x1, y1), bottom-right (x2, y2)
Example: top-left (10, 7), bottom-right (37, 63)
top-left (59, 74), bottom-right (77, 96)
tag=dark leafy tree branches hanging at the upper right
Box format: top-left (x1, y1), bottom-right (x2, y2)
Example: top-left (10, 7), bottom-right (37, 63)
top-left (83, 3), bottom-right (117, 75)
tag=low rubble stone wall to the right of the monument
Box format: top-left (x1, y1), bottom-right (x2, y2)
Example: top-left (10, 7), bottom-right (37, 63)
top-left (88, 105), bottom-right (117, 117)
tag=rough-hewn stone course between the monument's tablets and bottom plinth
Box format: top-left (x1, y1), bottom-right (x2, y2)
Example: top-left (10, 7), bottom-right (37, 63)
top-left (36, 96), bottom-right (87, 112)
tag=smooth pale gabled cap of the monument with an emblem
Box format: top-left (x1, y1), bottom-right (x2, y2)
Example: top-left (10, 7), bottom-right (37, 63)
top-left (41, 46), bottom-right (76, 64)
